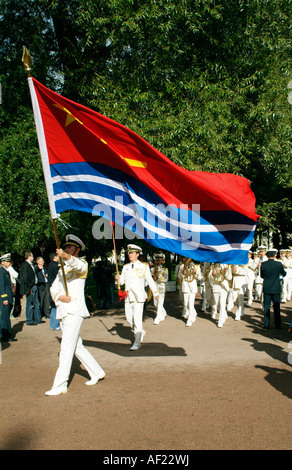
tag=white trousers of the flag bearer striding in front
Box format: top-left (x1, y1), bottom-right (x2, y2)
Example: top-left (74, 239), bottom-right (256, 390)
top-left (53, 315), bottom-right (104, 388)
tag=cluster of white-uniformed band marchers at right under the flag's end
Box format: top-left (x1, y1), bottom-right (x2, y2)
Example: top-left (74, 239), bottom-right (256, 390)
top-left (175, 246), bottom-right (292, 328)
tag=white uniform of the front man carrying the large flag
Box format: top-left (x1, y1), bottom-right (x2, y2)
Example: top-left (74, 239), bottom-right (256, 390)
top-left (50, 256), bottom-right (104, 389)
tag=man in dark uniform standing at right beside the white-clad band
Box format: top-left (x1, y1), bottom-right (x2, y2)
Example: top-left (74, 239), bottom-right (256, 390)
top-left (260, 249), bottom-right (286, 330)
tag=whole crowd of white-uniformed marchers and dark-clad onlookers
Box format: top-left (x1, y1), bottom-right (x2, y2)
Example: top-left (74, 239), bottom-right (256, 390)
top-left (0, 235), bottom-right (292, 395)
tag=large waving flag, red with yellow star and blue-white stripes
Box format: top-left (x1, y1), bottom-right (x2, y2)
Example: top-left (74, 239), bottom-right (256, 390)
top-left (29, 78), bottom-right (258, 263)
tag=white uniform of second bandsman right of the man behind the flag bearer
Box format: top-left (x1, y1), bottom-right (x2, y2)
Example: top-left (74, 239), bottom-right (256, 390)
top-left (178, 262), bottom-right (202, 326)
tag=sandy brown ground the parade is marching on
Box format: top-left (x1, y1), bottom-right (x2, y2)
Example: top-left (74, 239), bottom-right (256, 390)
top-left (0, 293), bottom-right (292, 451)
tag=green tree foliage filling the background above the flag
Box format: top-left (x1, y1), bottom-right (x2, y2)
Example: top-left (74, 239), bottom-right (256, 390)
top-left (0, 0), bottom-right (292, 258)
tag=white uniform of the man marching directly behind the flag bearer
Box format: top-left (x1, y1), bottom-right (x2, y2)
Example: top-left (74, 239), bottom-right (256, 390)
top-left (119, 260), bottom-right (158, 345)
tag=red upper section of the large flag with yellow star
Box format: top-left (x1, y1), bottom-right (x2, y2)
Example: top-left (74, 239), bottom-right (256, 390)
top-left (33, 79), bottom-right (258, 222)
